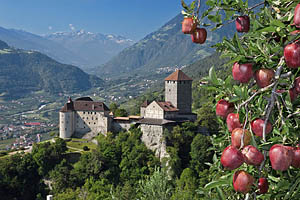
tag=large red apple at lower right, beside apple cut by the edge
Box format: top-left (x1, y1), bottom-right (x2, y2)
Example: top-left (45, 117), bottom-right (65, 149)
top-left (269, 144), bottom-right (293, 171)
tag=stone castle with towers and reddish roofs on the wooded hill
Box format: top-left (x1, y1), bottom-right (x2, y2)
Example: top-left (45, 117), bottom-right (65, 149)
top-left (59, 70), bottom-right (197, 158)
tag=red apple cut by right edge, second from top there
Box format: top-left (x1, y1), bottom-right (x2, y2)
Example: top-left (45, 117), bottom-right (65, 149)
top-left (283, 42), bottom-right (300, 68)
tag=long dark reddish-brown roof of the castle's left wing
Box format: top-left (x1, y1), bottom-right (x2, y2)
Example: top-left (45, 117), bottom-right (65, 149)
top-left (60, 101), bottom-right (109, 112)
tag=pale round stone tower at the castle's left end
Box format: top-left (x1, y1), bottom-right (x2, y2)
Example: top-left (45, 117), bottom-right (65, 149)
top-left (59, 97), bottom-right (74, 138)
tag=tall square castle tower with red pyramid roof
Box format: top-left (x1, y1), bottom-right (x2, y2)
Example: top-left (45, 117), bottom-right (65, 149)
top-left (165, 70), bottom-right (193, 114)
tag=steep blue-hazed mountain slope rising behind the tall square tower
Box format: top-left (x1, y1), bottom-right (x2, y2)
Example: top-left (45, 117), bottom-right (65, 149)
top-left (97, 14), bottom-right (235, 77)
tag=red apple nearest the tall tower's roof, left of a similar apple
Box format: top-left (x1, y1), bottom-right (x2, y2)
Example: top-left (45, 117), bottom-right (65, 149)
top-left (232, 62), bottom-right (253, 83)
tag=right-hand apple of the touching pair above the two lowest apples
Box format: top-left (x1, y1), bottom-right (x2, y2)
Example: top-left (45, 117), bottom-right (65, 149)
top-left (242, 145), bottom-right (264, 166)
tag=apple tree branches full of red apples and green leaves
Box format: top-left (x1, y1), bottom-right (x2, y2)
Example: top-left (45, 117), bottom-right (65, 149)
top-left (182, 0), bottom-right (300, 199)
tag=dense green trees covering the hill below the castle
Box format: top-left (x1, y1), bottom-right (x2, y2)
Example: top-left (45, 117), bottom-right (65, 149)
top-left (0, 123), bottom-right (213, 200)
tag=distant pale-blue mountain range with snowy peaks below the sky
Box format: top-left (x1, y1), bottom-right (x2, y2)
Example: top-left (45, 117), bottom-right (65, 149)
top-left (0, 27), bottom-right (134, 69)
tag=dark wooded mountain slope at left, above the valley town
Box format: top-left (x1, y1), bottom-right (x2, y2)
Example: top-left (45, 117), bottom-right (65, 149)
top-left (0, 41), bottom-right (103, 98)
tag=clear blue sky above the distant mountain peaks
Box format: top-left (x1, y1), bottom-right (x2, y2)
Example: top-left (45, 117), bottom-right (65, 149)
top-left (0, 0), bottom-right (192, 40)
